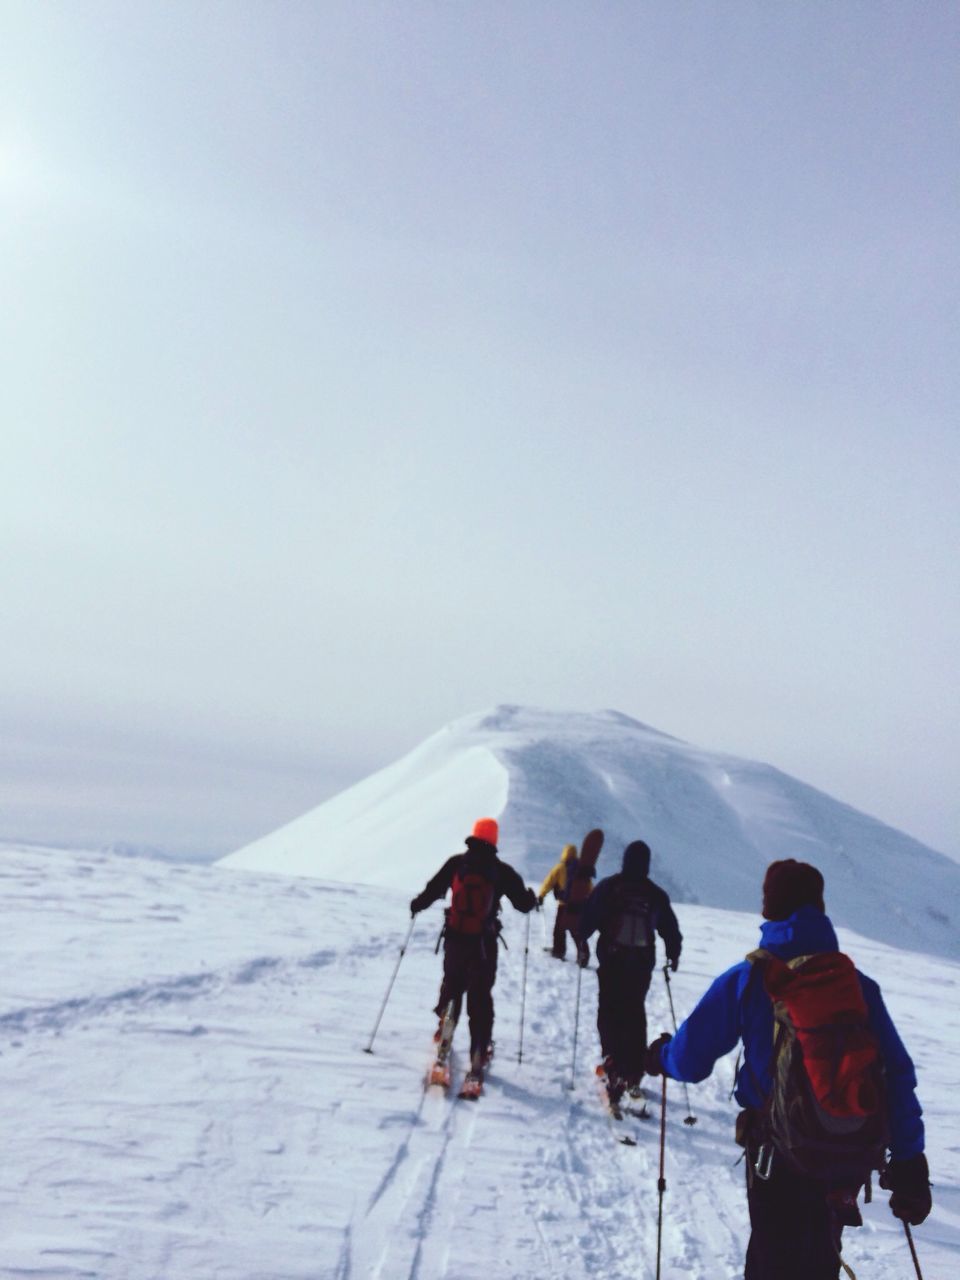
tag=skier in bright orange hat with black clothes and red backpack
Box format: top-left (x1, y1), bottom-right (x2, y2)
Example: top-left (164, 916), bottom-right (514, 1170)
top-left (410, 818), bottom-right (538, 1097)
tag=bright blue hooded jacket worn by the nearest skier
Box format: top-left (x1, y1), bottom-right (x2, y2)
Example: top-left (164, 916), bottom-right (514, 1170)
top-left (660, 906), bottom-right (923, 1160)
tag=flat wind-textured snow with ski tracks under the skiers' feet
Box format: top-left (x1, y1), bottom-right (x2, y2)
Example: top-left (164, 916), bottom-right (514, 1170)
top-left (0, 839), bottom-right (960, 1280)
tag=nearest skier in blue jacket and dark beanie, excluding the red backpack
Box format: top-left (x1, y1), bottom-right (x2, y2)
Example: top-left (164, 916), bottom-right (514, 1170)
top-left (644, 859), bottom-right (931, 1280)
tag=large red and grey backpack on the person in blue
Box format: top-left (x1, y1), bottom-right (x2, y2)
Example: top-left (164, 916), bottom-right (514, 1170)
top-left (748, 948), bottom-right (888, 1182)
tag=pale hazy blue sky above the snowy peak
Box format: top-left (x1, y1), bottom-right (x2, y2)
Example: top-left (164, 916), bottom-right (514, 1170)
top-left (0, 0), bottom-right (960, 856)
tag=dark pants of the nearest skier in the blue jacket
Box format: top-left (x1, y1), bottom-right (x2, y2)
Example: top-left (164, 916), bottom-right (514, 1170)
top-left (744, 1148), bottom-right (842, 1280)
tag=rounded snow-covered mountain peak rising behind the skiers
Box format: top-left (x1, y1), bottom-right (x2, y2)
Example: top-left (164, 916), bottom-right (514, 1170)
top-left (223, 707), bottom-right (960, 957)
